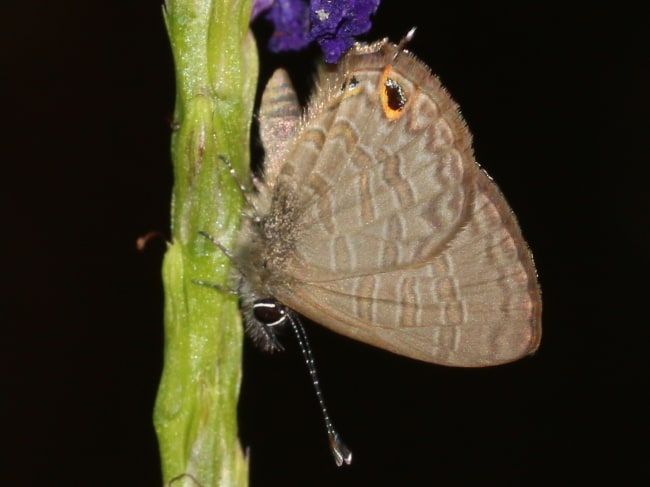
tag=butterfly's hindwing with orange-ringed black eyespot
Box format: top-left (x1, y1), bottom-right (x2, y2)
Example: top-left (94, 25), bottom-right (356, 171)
top-left (270, 44), bottom-right (479, 281)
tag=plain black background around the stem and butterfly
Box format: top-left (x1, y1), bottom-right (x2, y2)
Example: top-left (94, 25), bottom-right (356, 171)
top-left (0, 0), bottom-right (650, 487)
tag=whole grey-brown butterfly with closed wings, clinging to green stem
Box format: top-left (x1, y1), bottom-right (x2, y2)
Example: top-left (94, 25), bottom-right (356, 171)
top-left (233, 32), bottom-right (541, 464)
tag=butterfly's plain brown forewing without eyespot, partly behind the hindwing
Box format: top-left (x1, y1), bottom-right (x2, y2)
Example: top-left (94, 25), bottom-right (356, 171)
top-left (278, 172), bottom-right (541, 366)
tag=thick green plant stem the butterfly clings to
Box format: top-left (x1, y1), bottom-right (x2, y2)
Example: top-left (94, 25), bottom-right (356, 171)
top-left (154, 0), bottom-right (258, 487)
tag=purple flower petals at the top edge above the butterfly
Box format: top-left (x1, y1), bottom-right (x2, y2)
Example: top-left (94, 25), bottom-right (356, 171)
top-left (253, 0), bottom-right (379, 63)
